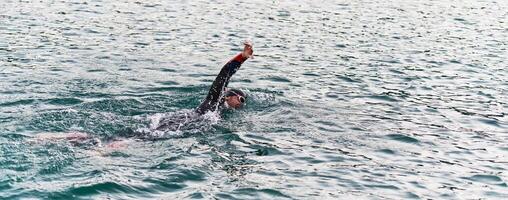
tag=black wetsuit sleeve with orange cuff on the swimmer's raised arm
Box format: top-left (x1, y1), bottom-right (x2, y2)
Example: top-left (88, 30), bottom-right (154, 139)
top-left (196, 54), bottom-right (247, 114)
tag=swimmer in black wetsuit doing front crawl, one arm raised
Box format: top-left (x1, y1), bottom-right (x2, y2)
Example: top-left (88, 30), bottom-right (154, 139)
top-left (33, 42), bottom-right (254, 146)
